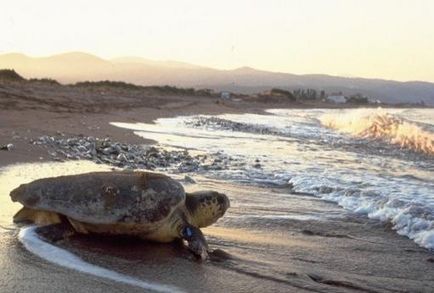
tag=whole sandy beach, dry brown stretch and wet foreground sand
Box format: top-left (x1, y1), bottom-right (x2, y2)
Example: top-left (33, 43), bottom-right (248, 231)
top-left (0, 83), bottom-right (434, 292)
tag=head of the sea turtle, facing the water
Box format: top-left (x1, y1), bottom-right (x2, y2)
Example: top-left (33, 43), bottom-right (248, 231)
top-left (185, 191), bottom-right (230, 228)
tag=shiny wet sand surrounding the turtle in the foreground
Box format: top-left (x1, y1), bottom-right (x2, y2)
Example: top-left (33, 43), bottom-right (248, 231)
top-left (0, 162), bottom-right (434, 292)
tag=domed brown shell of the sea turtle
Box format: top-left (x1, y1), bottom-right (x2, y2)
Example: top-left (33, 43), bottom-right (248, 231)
top-left (10, 171), bottom-right (185, 224)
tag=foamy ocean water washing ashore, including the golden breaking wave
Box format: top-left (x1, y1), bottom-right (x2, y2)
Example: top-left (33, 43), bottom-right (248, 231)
top-left (113, 109), bottom-right (434, 249)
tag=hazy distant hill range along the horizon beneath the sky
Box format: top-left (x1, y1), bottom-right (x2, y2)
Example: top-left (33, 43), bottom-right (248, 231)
top-left (0, 52), bottom-right (434, 105)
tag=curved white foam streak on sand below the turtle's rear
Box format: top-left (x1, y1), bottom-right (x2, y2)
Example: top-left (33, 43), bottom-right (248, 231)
top-left (18, 226), bottom-right (182, 292)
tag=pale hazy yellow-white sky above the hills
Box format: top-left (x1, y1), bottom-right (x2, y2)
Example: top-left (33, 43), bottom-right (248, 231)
top-left (0, 0), bottom-right (434, 81)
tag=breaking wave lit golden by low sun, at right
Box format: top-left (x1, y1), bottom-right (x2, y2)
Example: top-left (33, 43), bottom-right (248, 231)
top-left (319, 109), bottom-right (434, 155)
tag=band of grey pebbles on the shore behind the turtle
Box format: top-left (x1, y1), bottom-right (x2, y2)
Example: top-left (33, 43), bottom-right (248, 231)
top-left (31, 135), bottom-right (228, 173)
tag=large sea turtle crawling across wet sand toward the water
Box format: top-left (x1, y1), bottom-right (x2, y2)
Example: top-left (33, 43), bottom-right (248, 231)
top-left (10, 171), bottom-right (229, 259)
